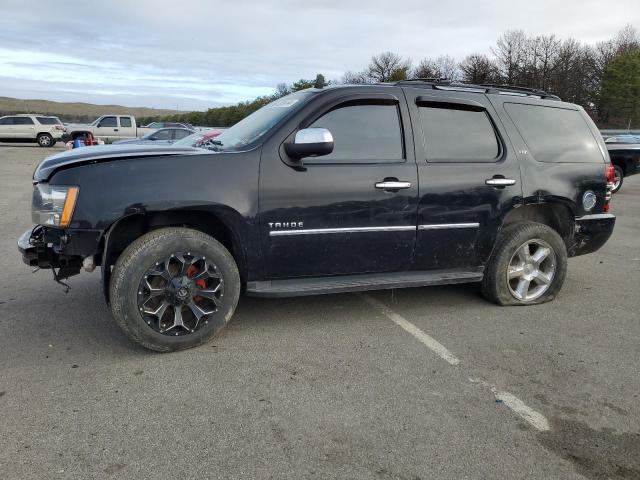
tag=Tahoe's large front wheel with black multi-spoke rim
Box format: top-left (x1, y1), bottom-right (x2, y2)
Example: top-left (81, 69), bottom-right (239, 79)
top-left (110, 227), bottom-right (240, 352)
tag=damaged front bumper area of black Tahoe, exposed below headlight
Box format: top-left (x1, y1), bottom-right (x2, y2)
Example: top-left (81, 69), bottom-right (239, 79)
top-left (18, 225), bottom-right (95, 290)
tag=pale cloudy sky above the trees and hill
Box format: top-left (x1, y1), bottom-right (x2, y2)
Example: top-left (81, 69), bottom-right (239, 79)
top-left (0, 0), bottom-right (640, 110)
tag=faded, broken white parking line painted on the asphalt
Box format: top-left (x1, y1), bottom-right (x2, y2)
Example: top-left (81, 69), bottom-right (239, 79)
top-left (361, 294), bottom-right (551, 432)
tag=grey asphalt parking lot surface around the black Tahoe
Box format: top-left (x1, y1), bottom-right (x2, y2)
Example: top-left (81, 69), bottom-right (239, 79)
top-left (0, 145), bottom-right (640, 480)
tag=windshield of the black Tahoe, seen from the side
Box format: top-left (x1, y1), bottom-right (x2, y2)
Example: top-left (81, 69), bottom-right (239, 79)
top-left (198, 91), bottom-right (312, 151)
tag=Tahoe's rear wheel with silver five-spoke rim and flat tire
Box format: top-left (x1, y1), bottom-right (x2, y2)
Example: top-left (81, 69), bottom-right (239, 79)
top-left (482, 222), bottom-right (567, 305)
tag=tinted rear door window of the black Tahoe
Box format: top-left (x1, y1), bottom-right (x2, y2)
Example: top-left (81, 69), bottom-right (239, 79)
top-left (418, 103), bottom-right (500, 163)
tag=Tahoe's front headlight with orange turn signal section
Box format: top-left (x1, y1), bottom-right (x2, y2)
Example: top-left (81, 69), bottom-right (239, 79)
top-left (31, 183), bottom-right (79, 227)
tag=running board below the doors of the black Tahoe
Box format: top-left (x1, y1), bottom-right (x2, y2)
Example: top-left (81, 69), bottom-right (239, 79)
top-left (247, 269), bottom-right (482, 297)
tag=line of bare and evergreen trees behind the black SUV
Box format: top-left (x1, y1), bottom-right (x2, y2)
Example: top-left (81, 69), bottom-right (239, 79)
top-left (142, 25), bottom-right (640, 129)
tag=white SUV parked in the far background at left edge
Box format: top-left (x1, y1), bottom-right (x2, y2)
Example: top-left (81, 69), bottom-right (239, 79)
top-left (0, 115), bottom-right (64, 147)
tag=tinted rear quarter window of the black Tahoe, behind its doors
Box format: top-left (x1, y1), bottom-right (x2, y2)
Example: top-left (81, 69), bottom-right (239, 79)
top-left (504, 103), bottom-right (604, 163)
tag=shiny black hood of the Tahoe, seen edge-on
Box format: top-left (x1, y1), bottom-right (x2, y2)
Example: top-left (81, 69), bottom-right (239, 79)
top-left (33, 145), bottom-right (202, 182)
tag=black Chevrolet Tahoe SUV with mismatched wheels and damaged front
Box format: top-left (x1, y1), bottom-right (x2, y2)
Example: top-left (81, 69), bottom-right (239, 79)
top-left (18, 81), bottom-right (615, 351)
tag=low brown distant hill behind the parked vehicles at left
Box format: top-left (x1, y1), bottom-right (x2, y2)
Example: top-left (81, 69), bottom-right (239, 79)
top-left (0, 97), bottom-right (187, 122)
